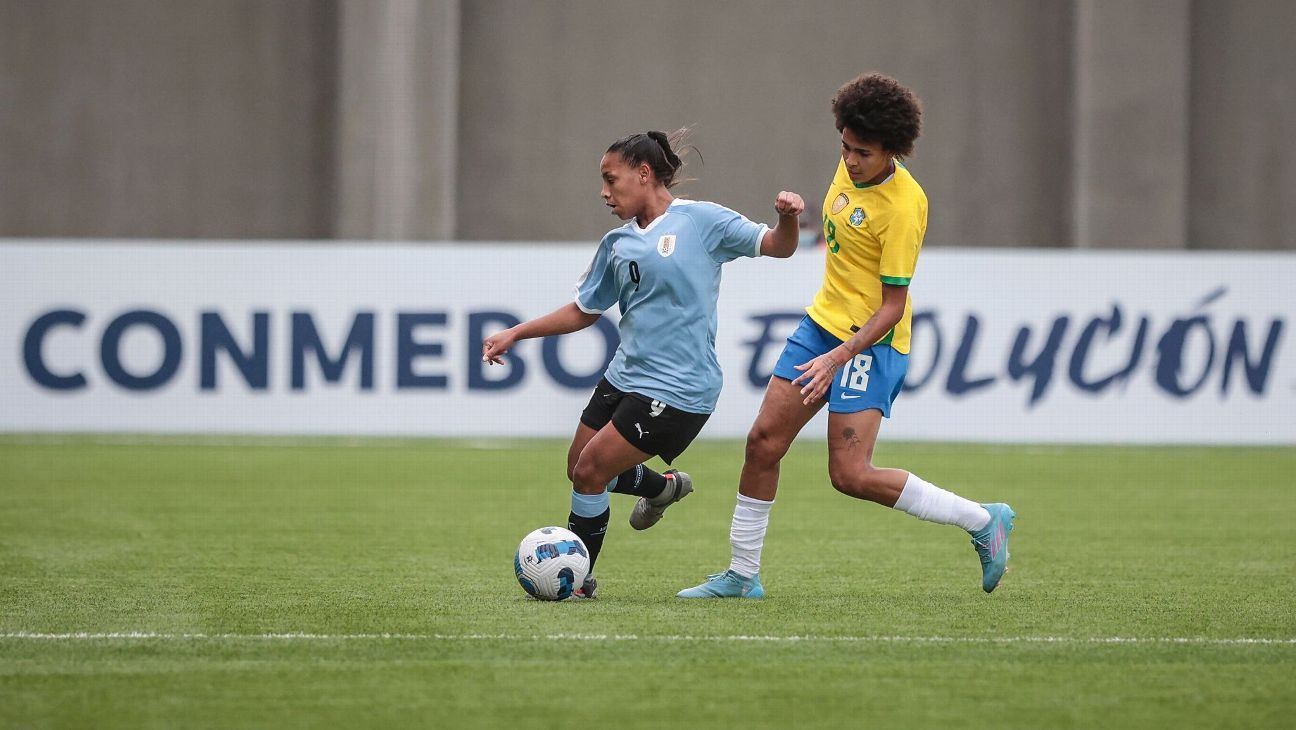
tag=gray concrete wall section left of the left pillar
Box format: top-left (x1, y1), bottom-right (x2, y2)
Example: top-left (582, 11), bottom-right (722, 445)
top-left (0, 0), bottom-right (337, 239)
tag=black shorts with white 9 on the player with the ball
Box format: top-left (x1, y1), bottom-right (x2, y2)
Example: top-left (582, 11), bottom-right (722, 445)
top-left (581, 377), bottom-right (712, 464)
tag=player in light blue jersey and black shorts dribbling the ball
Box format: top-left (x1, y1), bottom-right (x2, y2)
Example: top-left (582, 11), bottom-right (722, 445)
top-left (482, 130), bottom-right (805, 598)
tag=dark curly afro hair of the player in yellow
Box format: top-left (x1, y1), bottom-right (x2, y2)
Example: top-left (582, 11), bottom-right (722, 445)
top-left (832, 74), bottom-right (923, 158)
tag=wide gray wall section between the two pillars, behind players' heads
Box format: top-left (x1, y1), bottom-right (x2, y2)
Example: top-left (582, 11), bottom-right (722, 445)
top-left (459, 0), bottom-right (1070, 245)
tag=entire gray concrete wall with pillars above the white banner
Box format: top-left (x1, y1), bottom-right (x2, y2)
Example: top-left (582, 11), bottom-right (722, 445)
top-left (0, 0), bottom-right (1296, 249)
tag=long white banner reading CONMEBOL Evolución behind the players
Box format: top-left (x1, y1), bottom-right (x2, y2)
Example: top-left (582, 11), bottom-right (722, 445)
top-left (0, 241), bottom-right (1296, 443)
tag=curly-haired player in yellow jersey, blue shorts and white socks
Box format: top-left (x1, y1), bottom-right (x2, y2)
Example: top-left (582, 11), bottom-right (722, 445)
top-left (679, 74), bottom-right (1016, 598)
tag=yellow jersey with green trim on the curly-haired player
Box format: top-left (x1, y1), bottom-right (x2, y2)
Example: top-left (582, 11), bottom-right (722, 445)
top-left (806, 161), bottom-right (927, 355)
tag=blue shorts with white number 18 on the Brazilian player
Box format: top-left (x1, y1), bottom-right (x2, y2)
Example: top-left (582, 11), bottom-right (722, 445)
top-left (774, 315), bottom-right (908, 418)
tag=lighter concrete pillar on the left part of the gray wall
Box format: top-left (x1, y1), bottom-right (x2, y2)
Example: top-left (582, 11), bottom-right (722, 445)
top-left (334, 0), bottom-right (459, 240)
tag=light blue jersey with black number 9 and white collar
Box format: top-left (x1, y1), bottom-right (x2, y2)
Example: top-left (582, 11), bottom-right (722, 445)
top-left (575, 198), bottom-right (769, 414)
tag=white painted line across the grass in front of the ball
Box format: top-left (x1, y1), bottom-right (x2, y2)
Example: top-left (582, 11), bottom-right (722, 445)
top-left (0, 631), bottom-right (1296, 646)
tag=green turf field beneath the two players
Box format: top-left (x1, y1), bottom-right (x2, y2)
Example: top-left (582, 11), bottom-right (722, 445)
top-left (0, 436), bottom-right (1296, 727)
